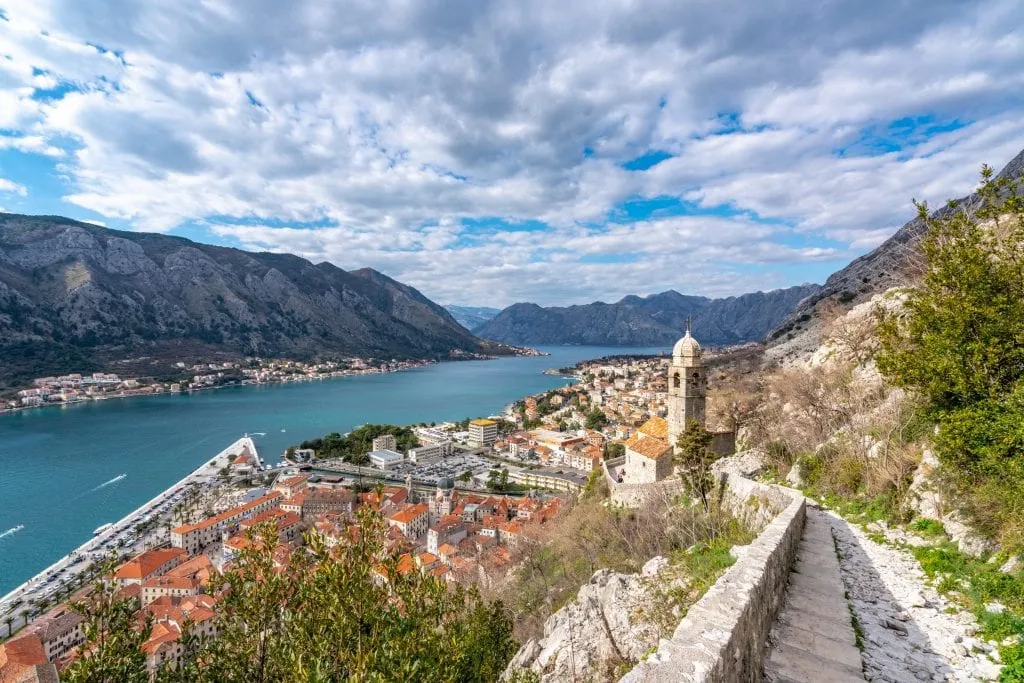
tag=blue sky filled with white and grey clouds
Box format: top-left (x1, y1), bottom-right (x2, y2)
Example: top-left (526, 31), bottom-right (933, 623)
top-left (0, 0), bottom-right (1024, 306)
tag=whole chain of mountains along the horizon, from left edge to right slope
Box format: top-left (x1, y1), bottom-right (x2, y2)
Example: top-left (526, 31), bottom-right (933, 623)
top-left (8, 144), bottom-right (1024, 390)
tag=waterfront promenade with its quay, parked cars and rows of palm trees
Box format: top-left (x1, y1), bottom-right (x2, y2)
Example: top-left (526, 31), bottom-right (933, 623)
top-left (0, 434), bottom-right (259, 627)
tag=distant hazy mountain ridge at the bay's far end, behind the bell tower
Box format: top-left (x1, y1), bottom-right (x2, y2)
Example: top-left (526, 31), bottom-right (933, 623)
top-left (475, 285), bottom-right (819, 346)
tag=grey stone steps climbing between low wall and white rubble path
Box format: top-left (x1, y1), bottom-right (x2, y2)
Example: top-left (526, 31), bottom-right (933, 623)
top-left (764, 507), bottom-right (864, 683)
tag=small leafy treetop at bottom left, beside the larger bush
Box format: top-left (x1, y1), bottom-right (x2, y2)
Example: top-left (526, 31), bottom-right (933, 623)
top-left (60, 554), bottom-right (153, 683)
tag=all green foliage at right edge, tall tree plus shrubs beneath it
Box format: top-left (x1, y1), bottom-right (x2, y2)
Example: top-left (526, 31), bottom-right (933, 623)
top-left (877, 167), bottom-right (1024, 550)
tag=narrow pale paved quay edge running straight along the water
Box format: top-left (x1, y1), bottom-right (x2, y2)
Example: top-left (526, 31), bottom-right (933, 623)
top-left (0, 434), bottom-right (253, 614)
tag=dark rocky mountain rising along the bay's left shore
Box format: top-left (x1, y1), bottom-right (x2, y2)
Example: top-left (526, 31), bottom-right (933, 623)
top-left (0, 214), bottom-right (503, 384)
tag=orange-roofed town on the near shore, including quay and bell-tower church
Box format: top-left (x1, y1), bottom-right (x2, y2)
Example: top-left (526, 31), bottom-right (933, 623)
top-left (0, 332), bottom-right (734, 672)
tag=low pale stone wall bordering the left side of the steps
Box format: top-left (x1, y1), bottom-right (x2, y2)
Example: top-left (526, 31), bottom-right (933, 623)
top-left (622, 474), bottom-right (806, 683)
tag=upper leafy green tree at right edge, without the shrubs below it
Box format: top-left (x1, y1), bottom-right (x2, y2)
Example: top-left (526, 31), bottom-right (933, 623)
top-left (877, 167), bottom-right (1024, 416)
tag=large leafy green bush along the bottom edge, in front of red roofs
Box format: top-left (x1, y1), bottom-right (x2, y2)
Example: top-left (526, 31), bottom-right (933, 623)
top-left (61, 511), bottom-right (518, 683)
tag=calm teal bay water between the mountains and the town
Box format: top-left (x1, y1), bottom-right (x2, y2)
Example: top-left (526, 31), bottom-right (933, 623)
top-left (0, 346), bottom-right (666, 595)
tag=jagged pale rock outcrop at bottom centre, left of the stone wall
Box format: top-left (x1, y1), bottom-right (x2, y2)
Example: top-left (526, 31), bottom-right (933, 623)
top-left (508, 557), bottom-right (668, 683)
